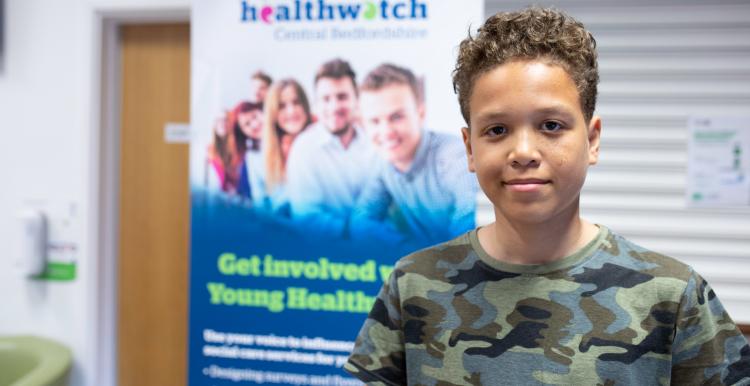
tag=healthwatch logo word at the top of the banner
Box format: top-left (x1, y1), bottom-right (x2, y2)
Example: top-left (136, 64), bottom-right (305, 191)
top-left (241, 0), bottom-right (427, 24)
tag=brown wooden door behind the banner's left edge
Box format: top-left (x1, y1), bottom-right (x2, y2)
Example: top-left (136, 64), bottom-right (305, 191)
top-left (118, 24), bottom-right (190, 386)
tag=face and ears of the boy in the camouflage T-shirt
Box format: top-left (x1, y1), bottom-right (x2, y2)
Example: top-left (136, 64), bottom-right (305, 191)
top-left (463, 61), bottom-right (601, 223)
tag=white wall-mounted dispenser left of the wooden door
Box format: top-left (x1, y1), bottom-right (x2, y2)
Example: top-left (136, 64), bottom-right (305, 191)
top-left (14, 209), bottom-right (47, 277)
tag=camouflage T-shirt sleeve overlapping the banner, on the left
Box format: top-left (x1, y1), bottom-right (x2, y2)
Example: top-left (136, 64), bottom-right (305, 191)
top-left (344, 270), bottom-right (406, 385)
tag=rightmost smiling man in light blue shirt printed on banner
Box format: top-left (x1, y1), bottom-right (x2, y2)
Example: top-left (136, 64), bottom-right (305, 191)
top-left (351, 64), bottom-right (478, 247)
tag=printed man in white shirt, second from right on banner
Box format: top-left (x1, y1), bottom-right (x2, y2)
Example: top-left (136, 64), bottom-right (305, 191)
top-left (287, 59), bottom-right (374, 238)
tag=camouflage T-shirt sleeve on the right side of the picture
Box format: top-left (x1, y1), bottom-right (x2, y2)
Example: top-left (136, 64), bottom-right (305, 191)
top-left (672, 273), bottom-right (750, 385)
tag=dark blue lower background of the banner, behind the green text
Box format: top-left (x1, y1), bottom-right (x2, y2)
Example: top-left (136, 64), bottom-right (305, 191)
top-left (189, 190), bottom-right (406, 385)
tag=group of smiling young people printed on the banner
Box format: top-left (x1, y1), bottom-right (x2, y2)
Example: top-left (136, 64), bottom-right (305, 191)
top-left (204, 58), bottom-right (478, 250)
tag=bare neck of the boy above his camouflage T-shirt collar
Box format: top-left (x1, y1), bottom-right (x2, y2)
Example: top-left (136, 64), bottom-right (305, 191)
top-left (477, 208), bottom-right (599, 264)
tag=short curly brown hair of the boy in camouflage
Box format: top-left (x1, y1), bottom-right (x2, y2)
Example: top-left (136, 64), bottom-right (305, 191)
top-left (453, 7), bottom-right (599, 126)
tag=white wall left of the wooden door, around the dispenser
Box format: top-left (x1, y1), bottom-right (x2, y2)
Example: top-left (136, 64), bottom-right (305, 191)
top-left (0, 0), bottom-right (190, 385)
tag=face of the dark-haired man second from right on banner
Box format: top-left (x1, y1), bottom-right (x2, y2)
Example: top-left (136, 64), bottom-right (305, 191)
top-left (315, 77), bottom-right (357, 135)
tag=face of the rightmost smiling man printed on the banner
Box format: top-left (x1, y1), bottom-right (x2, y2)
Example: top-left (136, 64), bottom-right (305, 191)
top-left (360, 84), bottom-right (424, 170)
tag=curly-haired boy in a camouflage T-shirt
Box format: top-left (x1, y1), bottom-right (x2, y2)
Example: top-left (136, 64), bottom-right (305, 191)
top-left (346, 8), bottom-right (750, 385)
